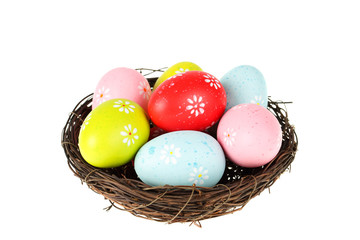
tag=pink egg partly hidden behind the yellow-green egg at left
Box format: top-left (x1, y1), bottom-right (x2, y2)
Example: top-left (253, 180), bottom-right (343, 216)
top-left (92, 67), bottom-right (151, 112)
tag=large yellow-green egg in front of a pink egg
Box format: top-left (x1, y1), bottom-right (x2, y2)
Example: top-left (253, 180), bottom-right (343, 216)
top-left (79, 99), bottom-right (150, 168)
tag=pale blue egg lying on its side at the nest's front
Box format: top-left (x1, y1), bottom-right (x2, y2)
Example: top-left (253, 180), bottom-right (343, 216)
top-left (134, 130), bottom-right (225, 187)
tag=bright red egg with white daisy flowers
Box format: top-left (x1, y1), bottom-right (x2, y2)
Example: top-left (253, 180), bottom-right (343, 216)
top-left (148, 71), bottom-right (226, 132)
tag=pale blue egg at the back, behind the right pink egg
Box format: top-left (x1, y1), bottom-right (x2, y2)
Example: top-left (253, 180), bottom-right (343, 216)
top-left (220, 65), bottom-right (268, 111)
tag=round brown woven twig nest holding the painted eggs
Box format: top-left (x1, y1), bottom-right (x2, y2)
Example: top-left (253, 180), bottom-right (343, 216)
top-left (61, 72), bottom-right (298, 226)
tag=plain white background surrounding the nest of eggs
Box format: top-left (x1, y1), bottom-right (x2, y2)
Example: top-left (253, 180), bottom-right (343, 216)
top-left (0, 0), bottom-right (360, 239)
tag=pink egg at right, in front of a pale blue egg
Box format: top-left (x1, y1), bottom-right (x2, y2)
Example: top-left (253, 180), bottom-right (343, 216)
top-left (217, 104), bottom-right (282, 168)
